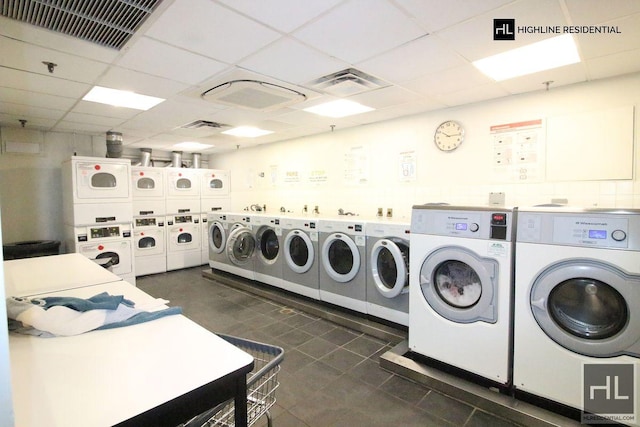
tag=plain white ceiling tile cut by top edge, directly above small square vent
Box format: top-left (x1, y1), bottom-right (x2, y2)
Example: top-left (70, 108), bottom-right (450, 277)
top-left (293, 0), bottom-right (425, 63)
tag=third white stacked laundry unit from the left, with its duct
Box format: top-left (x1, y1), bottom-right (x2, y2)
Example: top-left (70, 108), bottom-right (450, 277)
top-left (165, 152), bottom-right (202, 271)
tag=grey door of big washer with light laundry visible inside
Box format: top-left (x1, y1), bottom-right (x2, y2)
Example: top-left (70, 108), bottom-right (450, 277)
top-left (419, 246), bottom-right (506, 323)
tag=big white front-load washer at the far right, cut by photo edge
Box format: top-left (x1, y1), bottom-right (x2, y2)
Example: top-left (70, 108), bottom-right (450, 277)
top-left (513, 208), bottom-right (640, 425)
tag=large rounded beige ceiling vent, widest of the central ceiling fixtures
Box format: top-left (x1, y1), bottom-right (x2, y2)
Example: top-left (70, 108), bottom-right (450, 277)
top-left (201, 80), bottom-right (307, 111)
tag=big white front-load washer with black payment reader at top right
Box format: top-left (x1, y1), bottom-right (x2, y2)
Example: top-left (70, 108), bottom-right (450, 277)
top-left (409, 205), bottom-right (517, 386)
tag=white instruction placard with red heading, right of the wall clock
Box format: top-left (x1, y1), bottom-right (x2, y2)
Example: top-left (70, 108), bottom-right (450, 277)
top-left (490, 119), bottom-right (545, 182)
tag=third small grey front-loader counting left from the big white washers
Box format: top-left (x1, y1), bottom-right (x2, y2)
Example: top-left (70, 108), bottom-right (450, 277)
top-left (280, 216), bottom-right (320, 300)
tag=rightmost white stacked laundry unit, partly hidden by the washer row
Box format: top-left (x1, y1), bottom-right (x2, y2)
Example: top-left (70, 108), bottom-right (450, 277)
top-left (200, 166), bottom-right (231, 264)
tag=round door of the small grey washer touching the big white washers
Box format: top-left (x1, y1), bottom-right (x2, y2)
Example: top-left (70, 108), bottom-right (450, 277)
top-left (370, 239), bottom-right (409, 298)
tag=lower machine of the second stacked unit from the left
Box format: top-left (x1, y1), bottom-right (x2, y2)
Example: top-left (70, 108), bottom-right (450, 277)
top-left (133, 215), bottom-right (167, 276)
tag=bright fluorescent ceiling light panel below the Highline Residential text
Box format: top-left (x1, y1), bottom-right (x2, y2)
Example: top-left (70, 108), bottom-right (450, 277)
top-left (473, 34), bottom-right (580, 81)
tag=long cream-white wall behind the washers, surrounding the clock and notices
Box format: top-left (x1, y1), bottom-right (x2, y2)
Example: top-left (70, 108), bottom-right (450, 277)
top-left (209, 74), bottom-right (640, 218)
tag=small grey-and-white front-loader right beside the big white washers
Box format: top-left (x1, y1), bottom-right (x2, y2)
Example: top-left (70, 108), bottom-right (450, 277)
top-left (365, 220), bottom-right (410, 326)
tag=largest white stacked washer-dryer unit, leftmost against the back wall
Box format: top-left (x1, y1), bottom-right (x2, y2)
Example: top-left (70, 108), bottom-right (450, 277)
top-left (62, 156), bottom-right (135, 284)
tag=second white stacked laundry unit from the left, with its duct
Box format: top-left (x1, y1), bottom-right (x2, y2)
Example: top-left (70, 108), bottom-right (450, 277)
top-left (131, 150), bottom-right (167, 276)
